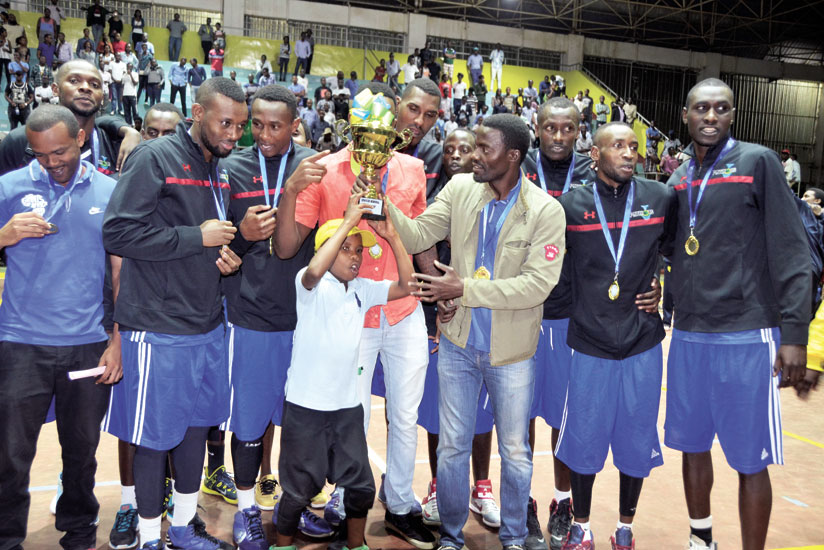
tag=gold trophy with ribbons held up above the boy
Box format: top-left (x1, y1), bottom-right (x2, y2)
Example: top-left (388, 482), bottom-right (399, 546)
top-left (335, 90), bottom-right (412, 220)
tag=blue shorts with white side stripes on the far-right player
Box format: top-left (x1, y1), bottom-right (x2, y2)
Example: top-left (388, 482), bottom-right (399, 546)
top-left (664, 328), bottom-right (784, 474)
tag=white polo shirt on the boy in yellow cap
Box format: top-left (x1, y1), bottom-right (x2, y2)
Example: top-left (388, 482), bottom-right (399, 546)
top-left (286, 267), bottom-right (392, 411)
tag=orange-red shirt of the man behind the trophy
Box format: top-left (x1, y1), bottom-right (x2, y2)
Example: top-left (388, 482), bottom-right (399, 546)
top-left (295, 149), bottom-right (426, 328)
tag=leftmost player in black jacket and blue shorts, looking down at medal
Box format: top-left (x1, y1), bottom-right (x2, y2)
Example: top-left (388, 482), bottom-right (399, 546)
top-left (103, 77), bottom-right (248, 550)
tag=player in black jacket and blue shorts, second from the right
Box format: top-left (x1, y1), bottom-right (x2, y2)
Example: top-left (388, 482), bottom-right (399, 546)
top-left (555, 122), bottom-right (675, 550)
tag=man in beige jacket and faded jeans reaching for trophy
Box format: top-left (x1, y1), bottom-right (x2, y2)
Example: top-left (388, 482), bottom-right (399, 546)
top-left (387, 114), bottom-right (566, 550)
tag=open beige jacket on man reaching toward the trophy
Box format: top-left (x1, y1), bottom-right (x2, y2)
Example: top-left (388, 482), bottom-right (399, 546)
top-left (387, 174), bottom-right (566, 366)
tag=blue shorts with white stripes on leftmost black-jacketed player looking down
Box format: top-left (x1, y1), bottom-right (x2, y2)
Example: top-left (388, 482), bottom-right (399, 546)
top-left (102, 324), bottom-right (229, 451)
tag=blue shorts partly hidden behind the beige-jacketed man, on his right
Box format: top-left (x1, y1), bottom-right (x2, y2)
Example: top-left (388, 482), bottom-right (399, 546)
top-left (532, 319), bottom-right (572, 428)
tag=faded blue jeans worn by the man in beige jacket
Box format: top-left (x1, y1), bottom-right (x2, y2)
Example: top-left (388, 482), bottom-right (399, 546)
top-left (438, 338), bottom-right (535, 548)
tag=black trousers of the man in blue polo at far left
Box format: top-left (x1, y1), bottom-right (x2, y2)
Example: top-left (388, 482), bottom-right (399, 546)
top-left (0, 341), bottom-right (111, 550)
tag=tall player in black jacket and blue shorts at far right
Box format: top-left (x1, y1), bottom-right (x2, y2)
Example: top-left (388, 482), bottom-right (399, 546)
top-left (665, 79), bottom-right (814, 550)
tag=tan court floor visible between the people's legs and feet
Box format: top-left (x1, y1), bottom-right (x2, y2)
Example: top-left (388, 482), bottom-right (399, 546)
top-left (26, 332), bottom-right (824, 550)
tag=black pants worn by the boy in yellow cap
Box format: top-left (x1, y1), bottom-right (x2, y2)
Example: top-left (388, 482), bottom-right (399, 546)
top-left (277, 401), bottom-right (375, 536)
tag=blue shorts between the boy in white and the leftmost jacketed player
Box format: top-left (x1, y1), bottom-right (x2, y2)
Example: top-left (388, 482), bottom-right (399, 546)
top-left (221, 323), bottom-right (294, 441)
